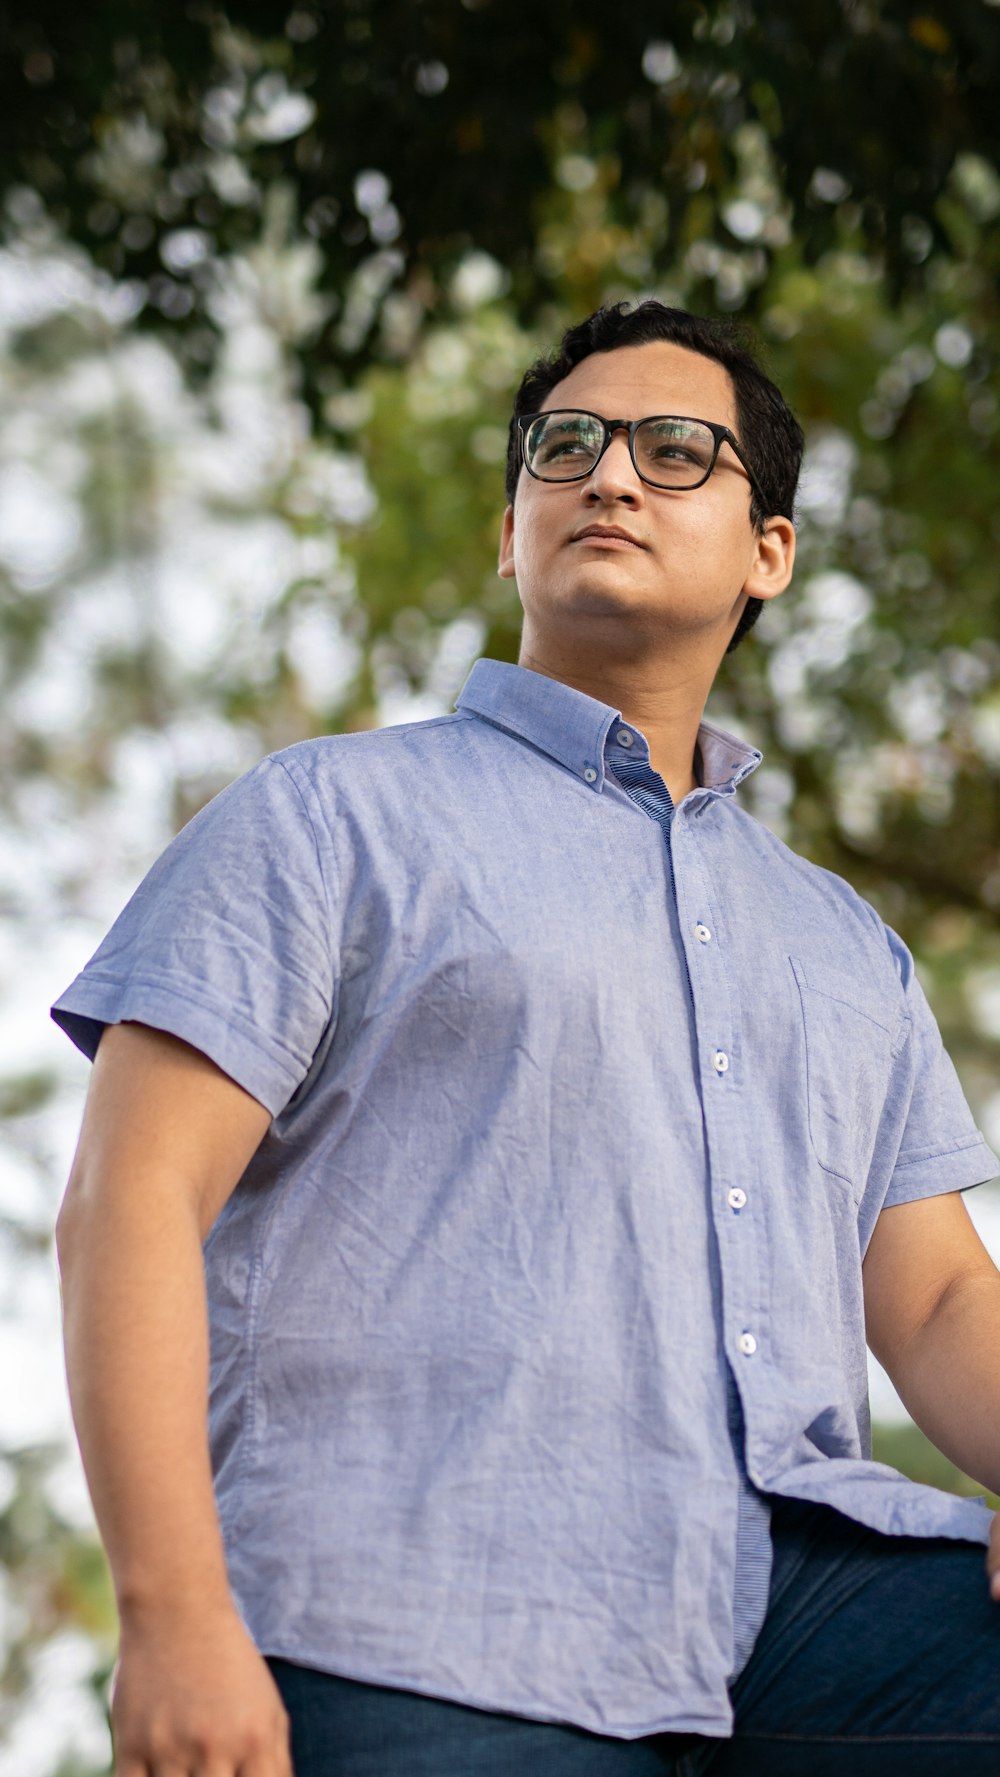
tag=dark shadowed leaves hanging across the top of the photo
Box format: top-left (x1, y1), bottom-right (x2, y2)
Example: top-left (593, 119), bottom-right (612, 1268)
top-left (0, 0), bottom-right (1000, 392)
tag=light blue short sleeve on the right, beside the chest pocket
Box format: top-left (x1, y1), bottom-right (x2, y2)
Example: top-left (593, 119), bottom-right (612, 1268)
top-left (885, 931), bottom-right (1000, 1205)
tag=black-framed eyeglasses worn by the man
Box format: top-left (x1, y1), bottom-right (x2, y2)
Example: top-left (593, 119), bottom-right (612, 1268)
top-left (517, 407), bottom-right (766, 506)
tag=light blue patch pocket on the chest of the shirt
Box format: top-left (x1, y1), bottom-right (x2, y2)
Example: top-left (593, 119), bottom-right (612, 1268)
top-left (789, 956), bottom-right (909, 1198)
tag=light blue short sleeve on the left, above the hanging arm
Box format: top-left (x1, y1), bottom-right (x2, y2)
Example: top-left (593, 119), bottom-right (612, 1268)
top-left (52, 759), bottom-right (336, 1116)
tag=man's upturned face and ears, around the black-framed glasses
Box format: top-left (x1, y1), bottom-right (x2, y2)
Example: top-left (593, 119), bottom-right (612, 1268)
top-left (499, 341), bottom-right (794, 654)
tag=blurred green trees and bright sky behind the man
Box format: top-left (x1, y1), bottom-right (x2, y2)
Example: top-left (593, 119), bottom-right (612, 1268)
top-left (0, 0), bottom-right (1000, 1777)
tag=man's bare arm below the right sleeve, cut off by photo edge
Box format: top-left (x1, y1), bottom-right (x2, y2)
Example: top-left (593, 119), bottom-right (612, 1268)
top-left (863, 1192), bottom-right (1000, 1599)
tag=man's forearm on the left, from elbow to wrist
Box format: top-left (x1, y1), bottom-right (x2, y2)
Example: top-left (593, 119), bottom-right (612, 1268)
top-left (59, 1176), bottom-right (229, 1617)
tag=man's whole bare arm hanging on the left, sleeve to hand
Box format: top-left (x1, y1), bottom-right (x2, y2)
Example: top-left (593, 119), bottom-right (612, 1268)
top-left (57, 1025), bottom-right (291, 1777)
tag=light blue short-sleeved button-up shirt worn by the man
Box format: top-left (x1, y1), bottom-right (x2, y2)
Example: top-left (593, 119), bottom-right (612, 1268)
top-left (55, 661), bottom-right (996, 1738)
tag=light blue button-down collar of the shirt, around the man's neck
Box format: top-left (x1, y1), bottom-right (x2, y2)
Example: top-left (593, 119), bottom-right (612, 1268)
top-left (456, 659), bottom-right (762, 796)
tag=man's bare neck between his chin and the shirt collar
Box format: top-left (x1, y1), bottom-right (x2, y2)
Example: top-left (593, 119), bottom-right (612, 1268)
top-left (519, 627), bottom-right (718, 803)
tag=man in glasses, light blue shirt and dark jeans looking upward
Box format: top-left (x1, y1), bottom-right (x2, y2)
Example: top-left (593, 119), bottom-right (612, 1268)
top-left (55, 302), bottom-right (1000, 1777)
